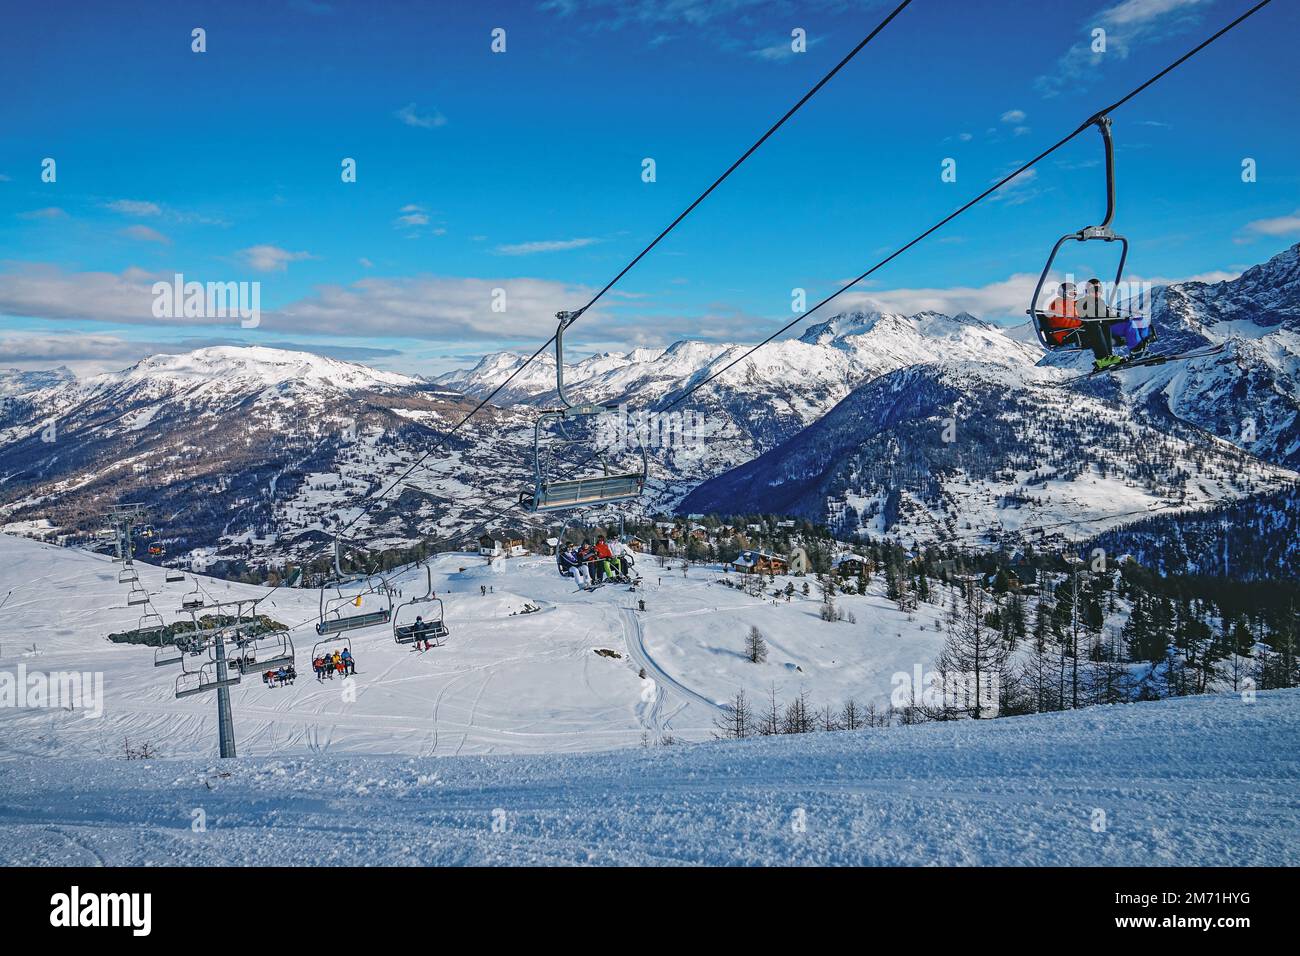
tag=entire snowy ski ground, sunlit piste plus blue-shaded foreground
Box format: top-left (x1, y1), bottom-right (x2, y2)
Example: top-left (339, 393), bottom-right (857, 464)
top-left (0, 537), bottom-right (1300, 865)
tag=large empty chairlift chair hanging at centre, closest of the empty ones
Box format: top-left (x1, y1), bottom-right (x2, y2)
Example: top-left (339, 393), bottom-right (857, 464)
top-left (519, 311), bottom-right (650, 511)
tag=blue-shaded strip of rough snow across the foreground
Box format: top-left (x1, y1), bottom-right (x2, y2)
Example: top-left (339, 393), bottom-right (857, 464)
top-left (0, 691), bottom-right (1300, 866)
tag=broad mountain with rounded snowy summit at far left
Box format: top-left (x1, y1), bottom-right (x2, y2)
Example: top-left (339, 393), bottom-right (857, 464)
top-left (0, 347), bottom-right (523, 557)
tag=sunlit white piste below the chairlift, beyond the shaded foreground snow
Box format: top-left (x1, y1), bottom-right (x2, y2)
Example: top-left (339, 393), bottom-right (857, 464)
top-left (0, 535), bottom-right (941, 761)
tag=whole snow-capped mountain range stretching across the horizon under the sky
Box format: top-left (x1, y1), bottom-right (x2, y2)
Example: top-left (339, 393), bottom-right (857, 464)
top-left (0, 246), bottom-right (1300, 567)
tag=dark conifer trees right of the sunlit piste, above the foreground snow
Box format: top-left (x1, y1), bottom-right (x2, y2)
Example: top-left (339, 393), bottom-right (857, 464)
top-left (716, 553), bottom-right (1300, 739)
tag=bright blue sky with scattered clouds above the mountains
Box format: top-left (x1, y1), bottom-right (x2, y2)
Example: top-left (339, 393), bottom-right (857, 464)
top-left (0, 0), bottom-right (1300, 375)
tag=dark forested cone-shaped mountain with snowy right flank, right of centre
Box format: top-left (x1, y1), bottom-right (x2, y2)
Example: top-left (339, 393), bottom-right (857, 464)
top-left (681, 362), bottom-right (1295, 544)
